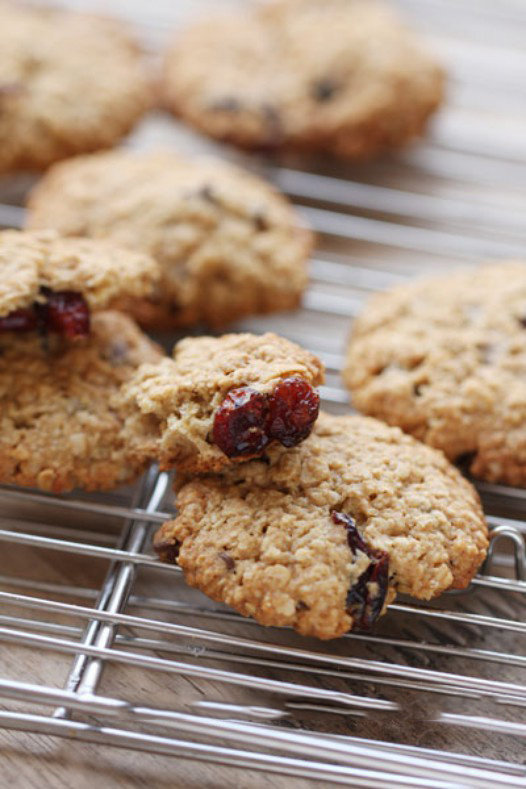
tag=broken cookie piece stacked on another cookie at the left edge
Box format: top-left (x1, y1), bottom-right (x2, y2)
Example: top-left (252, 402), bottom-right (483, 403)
top-left (0, 226), bottom-right (162, 492)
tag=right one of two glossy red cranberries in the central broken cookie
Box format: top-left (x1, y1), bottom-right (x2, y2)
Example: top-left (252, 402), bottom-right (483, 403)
top-left (267, 377), bottom-right (320, 447)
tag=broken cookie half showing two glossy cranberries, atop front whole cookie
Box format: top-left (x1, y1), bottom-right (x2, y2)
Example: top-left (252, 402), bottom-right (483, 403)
top-left (122, 333), bottom-right (324, 473)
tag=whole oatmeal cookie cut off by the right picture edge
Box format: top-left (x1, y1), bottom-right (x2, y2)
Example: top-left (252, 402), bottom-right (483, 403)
top-left (344, 262), bottom-right (526, 486)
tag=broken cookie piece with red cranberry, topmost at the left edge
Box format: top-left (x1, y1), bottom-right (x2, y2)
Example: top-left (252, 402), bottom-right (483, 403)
top-left (0, 230), bottom-right (159, 337)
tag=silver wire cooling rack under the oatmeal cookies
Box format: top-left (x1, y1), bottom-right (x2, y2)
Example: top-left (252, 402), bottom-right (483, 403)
top-left (0, 0), bottom-right (526, 789)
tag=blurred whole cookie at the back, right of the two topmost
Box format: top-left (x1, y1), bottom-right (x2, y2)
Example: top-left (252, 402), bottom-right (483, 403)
top-left (164, 0), bottom-right (444, 159)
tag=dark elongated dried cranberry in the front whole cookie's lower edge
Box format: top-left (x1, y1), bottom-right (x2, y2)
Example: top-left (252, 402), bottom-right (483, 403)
top-left (332, 512), bottom-right (389, 630)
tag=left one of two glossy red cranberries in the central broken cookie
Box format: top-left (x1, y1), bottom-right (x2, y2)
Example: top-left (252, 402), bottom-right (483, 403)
top-left (212, 386), bottom-right (269, 457)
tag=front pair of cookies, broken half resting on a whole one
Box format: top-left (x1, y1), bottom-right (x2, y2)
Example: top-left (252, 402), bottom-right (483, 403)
top-left (118, 334), bottom-right (487, 638)
